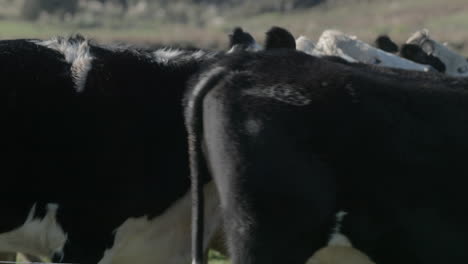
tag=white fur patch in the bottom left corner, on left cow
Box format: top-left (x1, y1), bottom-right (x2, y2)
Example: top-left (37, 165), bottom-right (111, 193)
top-left (0, 204), bottom-right (67, 258)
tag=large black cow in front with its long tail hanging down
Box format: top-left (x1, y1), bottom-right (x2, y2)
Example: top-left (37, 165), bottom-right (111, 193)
top-left (185, 49), bottom-right (468, 264)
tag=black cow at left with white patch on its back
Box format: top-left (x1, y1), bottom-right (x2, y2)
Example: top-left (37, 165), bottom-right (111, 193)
top-left (0, 36), bottom-right (218, 264)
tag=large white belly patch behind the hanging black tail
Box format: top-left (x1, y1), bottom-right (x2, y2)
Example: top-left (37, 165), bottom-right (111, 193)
top-left (99, 182), bottom-right (221, 264)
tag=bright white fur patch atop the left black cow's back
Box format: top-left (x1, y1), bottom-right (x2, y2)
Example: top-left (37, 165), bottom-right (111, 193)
top-left (34, 38), bottom-right (93, 93)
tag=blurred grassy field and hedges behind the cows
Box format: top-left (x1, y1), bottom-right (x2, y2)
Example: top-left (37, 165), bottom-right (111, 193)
top-left (0, 0), bottom-right (468, 52)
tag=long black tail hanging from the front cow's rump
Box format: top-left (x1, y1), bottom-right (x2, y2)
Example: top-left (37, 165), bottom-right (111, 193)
top-left (185, 67), bottom-right (229, 264)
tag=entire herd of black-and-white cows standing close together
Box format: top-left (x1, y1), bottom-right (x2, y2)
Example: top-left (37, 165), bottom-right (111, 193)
top-left (0, 24), bottom-right (468, 264)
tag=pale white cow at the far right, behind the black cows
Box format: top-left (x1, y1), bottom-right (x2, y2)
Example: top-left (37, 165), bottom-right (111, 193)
top-left (406, 29), bottom-right (468, 77)
